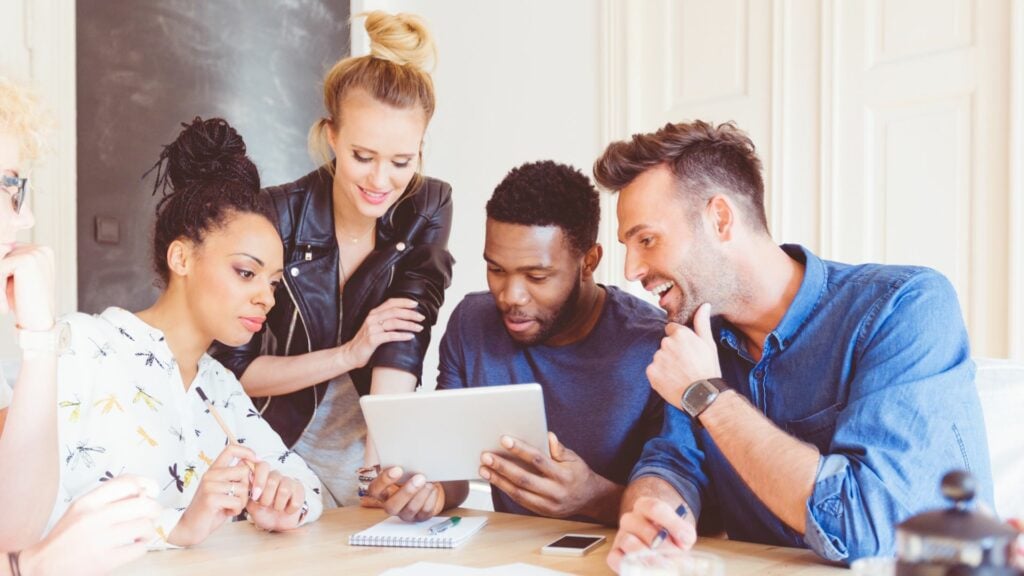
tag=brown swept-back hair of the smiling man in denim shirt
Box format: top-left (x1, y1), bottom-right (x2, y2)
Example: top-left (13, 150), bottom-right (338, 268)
top-left (594, 120), bottom-right (768, 232)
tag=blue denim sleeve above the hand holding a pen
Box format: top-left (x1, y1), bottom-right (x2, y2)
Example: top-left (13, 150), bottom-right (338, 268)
top-left (630, 405), bottom-right (708, 518)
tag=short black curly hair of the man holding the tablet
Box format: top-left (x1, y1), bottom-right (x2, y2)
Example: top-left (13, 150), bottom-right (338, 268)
top-left (487, 160), bottom-right (601, 254)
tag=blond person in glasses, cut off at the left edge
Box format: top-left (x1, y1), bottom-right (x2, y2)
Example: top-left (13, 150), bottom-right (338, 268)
top-left (0, 76), bottom-right (160, 576)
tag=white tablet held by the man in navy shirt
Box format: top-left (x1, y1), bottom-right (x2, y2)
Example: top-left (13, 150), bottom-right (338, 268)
top-left (359, 384), bottom-right (550, 482)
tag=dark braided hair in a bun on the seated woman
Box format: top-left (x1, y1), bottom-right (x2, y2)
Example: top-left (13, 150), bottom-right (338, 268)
top-left (143, 116), bottom-right (273, 286)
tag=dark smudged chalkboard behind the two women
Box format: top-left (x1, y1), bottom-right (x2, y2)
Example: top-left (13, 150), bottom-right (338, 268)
top-left (77, 0), bottom-right (349, 313)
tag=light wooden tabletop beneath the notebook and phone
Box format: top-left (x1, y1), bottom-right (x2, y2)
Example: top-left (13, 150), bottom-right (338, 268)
top-left (116, 507), bottom-right (847, 576)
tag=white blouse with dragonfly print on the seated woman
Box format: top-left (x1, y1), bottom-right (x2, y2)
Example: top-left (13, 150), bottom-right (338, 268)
top-left (47, 307), bottom-right (323, 547)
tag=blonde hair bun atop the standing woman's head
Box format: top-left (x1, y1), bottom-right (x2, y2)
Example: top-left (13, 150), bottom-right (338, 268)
top-left (364, 10), bottom-right (437, 71)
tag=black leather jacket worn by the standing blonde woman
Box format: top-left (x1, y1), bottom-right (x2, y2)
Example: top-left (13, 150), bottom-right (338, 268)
top-left (213, 167), bottom-right (454, 447)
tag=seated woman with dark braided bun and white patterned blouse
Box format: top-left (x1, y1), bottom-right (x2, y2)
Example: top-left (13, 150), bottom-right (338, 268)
top-left (45, 118), bottom-right (322, 546)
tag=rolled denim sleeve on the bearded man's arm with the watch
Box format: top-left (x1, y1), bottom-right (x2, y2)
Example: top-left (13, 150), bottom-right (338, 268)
top-left (804, 271), bottom-right (992, 562)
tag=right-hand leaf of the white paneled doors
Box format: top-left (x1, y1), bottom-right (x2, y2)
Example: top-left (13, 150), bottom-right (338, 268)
top-left (822, 0), bottom-right (1010, 356)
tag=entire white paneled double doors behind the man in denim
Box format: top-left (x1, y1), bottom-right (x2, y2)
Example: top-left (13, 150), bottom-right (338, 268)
top-left (607, 0), bottom-right (1024, 357)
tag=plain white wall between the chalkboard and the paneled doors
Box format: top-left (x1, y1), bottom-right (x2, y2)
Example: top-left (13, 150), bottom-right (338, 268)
top-left (352, 0), bottom-right (613, 387)
